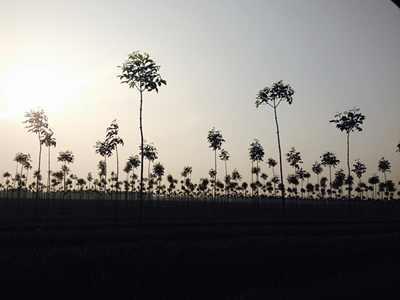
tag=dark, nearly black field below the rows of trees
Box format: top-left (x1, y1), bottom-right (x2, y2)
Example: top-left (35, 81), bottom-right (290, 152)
top-left (0, 196), bottom-right (400, 300)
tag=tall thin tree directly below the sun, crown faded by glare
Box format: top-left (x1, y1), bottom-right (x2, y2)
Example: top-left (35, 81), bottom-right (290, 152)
top-left (22, 107), bottom-right (49, 238)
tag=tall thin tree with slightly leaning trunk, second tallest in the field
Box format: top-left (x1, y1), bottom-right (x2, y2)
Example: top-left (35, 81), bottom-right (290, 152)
top-left (255, 80), bottom-right (294, 281)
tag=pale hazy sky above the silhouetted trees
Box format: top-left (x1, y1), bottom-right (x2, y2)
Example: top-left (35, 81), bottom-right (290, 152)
top-left (0, 0), bottom-right (400, 188)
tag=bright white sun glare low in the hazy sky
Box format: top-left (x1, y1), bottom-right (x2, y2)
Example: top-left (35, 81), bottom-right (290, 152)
top-left (5, 67), bottom-right (84, 112)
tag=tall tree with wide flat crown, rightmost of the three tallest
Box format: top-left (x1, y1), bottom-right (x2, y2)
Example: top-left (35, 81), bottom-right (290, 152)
top-left (329, 107), bottom-right (365, 200)
